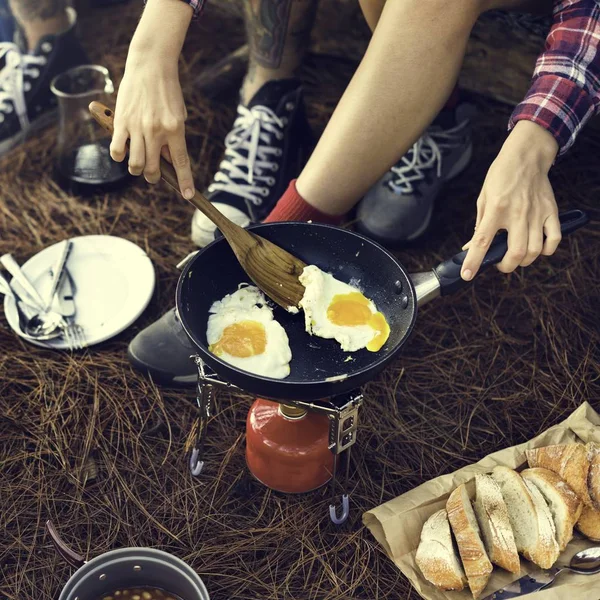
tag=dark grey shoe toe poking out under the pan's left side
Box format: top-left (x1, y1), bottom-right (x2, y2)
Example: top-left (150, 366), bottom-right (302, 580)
top-left (127, 308), bottom-right (198, 386)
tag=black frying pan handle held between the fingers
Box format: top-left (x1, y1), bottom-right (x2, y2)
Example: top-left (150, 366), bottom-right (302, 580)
top-left (434, 210), bottom-right (590, 296)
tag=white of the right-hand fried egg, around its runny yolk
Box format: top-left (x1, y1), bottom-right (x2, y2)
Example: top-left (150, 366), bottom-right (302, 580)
top-left (299, 265), bottom-right (377, 352)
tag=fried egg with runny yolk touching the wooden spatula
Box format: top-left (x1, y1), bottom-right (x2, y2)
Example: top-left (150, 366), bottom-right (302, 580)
top-left (299, 265), bottom-right (390, 352)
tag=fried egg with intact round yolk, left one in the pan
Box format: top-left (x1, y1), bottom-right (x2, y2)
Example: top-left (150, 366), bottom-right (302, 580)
top-left (206, 284), bottom-right (292, 379)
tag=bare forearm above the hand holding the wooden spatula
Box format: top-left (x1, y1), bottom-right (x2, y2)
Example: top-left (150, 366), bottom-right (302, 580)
top-left (126, 0), bottom-right (194, 69)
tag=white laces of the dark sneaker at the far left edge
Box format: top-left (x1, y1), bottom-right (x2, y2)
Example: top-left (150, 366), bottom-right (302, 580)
top-left (0, 42), bottom-right (47, 129)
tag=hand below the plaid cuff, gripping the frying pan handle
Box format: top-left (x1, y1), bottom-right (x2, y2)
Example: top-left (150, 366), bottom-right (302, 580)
top-left (461, 121), bottom-right (561, 281)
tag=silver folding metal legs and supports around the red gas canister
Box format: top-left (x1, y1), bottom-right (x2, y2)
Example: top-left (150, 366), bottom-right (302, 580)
top-left (189, 355), bottom-right (363, 525)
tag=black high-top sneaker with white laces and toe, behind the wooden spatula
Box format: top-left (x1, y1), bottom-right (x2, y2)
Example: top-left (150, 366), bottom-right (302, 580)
top-left (192, 79), bottom-right (313, 247)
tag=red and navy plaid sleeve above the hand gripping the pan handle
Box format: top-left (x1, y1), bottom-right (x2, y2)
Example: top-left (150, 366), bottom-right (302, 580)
top-left (509, 0), bottom-right (600, 155)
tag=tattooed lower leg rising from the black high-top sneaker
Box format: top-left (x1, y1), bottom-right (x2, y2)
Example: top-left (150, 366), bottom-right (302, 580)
top-left (242, 0), bottom-right (317, 103)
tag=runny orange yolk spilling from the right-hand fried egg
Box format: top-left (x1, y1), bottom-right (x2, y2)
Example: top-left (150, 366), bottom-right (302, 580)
top-left (327, 292), bottom-right (390, 352)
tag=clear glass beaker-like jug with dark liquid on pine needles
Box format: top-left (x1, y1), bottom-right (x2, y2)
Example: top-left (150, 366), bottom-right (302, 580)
top-left (50, 65), bottom-right (129, 194)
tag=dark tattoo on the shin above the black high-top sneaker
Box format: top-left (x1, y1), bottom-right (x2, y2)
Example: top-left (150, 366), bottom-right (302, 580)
top-left (245, 0), bottom-right (317, 69)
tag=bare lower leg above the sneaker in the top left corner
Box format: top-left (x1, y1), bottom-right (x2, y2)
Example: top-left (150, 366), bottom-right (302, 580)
top-left (10, 0), bottom-right (69, 50)
